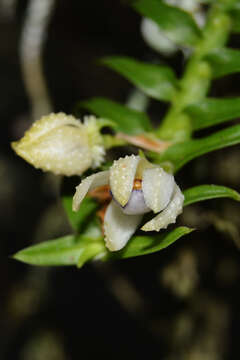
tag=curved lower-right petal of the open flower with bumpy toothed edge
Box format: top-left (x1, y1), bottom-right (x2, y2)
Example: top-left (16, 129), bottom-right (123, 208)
top-left (141, 185), bottom-right (184, 231)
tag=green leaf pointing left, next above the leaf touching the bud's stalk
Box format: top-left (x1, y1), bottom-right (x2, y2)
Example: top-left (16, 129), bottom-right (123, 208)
top-left (101, 56), bottom-right (177, 100)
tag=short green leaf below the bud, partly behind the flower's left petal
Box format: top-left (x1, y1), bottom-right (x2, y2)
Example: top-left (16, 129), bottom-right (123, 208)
top-left (62, 196), bottom-right (98, 233)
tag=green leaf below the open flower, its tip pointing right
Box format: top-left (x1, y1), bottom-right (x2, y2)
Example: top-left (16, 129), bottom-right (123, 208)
top-left (108, 226), bottom-right (193, 259)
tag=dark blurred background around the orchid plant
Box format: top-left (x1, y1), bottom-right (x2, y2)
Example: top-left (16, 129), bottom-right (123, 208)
top-left (0, 0), bottom-right (240, 360)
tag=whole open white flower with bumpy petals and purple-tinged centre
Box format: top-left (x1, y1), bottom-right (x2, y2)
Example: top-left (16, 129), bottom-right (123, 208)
top-left (73, 155), bottom-right (184, 251)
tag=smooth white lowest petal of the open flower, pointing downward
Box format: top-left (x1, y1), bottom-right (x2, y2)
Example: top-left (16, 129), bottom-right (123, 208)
top-left (104, 200), bottom-right (142, 251)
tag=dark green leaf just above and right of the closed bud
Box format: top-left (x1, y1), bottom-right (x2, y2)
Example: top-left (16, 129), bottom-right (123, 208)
top-left (80, 97), bottom-right (152, 135)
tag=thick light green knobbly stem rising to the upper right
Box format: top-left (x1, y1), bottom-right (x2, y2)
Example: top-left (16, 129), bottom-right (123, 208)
top-left (156, 3), bottom-right (231, 142)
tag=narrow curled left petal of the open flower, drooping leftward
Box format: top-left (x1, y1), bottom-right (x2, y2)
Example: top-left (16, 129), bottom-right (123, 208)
top-left (73, 170), bottom-right (109, 211)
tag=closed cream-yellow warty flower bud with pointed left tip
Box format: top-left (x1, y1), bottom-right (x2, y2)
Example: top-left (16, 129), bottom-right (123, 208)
top-left (12, 113), bottom-right (105, 176)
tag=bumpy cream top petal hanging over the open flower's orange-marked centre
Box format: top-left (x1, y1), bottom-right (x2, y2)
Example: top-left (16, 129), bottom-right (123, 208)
top-left (110, 155), bottom-right (140, 206)
